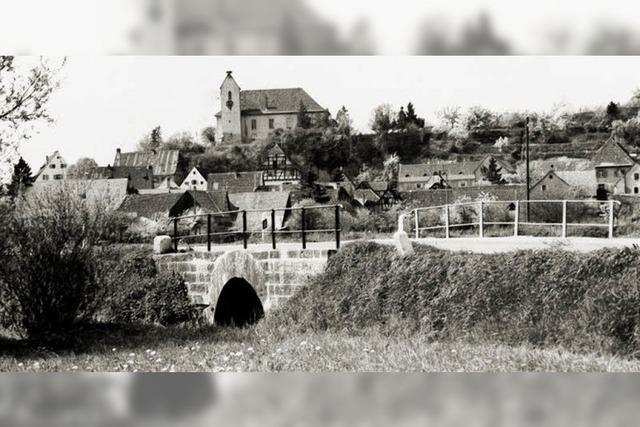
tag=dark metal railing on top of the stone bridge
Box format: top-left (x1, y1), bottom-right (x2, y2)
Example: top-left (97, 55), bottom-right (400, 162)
top-left (171, 205), bottom-right (342, 252)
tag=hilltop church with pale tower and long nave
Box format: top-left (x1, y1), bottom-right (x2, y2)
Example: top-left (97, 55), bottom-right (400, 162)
top-left (216, 71), bottom-right (327, 143)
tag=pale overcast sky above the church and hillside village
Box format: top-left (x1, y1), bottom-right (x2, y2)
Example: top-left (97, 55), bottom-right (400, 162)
top-left (21, 56), bottom-right (640, 168)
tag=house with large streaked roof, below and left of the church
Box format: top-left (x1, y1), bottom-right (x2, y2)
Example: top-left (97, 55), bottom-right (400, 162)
top-left (113, 148), bottom-right (186, 188)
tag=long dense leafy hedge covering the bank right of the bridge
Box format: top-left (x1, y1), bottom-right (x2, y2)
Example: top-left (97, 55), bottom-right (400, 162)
top-left (274, 243), bottom-right (640, 354)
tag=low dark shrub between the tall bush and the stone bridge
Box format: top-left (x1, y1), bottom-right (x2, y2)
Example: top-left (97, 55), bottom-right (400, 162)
top-left (100, 249), bottom-right (192, 326)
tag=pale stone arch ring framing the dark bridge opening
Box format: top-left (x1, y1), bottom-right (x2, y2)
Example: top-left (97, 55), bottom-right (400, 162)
top-left (207, 250), bottom-right (267, 323)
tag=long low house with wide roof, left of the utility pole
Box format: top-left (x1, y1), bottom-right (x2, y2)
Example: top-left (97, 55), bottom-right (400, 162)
top-left (398, 156), bottom-right (513, 192)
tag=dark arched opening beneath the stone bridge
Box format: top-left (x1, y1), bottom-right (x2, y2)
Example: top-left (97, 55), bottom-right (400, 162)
top-left (213, 277), bottom-right (264, 327)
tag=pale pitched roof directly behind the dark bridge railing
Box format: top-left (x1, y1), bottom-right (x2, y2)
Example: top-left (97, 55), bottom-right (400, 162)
top-left (229, 191), bottom-right (291, 231)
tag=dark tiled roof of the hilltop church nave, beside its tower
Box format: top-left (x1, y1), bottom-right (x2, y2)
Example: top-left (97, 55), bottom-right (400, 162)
top-left (240, 88), bottom-right (324, 114)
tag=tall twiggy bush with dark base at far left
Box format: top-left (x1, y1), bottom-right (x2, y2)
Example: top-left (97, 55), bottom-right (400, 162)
top-left (0, 187), bottom-right (108, 339)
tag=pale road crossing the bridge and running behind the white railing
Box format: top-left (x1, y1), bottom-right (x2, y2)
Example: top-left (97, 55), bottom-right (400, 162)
top-left (186, 236), bottom-right (640, 253)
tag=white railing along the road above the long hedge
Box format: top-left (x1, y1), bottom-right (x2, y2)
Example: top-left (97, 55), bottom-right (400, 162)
top-left (414, 200), bottom-right (620, 239)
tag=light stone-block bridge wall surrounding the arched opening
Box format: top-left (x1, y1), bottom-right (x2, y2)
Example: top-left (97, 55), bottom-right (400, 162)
top-left (154, 248), bottom-right (336, 323)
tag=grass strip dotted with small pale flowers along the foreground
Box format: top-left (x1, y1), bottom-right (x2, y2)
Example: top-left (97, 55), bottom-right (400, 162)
top-left (0, 321), bottom-right (640, 372)
